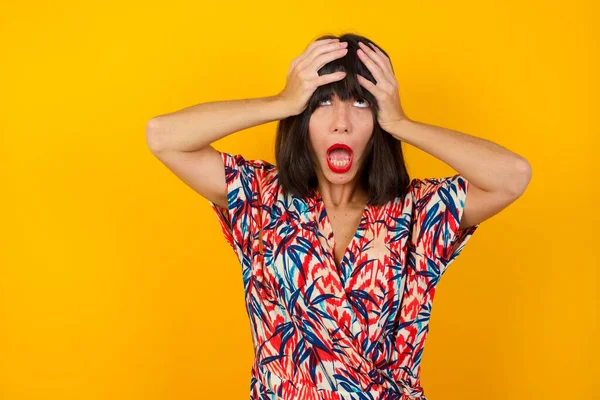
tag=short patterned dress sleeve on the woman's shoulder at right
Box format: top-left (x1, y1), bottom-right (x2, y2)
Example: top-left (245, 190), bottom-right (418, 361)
top-left (413, 174), bottom-right (479, 277)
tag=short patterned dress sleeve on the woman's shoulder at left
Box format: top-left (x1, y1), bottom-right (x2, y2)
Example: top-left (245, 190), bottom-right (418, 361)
top-left (209, 151), bottom-right (264, 265)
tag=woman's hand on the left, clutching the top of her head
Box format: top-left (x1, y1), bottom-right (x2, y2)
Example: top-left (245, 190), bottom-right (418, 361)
top-left (277, 38), bottom-right (348, 115)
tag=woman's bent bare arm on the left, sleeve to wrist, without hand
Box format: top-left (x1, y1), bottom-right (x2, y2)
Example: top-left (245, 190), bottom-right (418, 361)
top-left (146, 96), bottom-right (290, 208)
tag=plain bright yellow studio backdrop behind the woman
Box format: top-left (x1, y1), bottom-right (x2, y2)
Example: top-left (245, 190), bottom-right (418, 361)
top-left (0, 0), bottom-right (600, 400)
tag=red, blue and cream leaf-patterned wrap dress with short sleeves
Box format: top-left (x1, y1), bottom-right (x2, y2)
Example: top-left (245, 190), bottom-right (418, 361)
top-left (210, 152), bottom-right (479, 400)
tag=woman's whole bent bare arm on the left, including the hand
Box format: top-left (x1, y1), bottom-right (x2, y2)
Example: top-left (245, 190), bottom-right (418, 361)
top-left (146, 39), bottom-right (346, 208)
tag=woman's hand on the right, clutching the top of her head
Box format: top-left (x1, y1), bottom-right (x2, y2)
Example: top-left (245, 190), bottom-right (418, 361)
top-left (356, 42), bottom-right (409, 132)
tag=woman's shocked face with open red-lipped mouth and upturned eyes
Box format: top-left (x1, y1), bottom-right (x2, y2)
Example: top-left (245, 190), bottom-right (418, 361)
top-left (308, 93), bottom-right (373, 188)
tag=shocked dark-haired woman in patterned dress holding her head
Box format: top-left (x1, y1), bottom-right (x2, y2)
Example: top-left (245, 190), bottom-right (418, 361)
top-left (147, 34), bottom-right (531, 400)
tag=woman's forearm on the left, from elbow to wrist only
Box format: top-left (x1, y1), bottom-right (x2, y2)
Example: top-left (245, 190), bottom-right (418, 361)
top-left (146, 96), bottom-right (290, 151)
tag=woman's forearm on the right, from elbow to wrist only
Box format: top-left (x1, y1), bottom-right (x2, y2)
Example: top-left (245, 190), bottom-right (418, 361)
top-left (390, 119), bottom-right (531, 194)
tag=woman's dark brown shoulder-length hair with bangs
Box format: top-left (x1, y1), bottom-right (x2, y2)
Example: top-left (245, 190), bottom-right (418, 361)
top-left (275, 33), bottom-right (410, 205)
